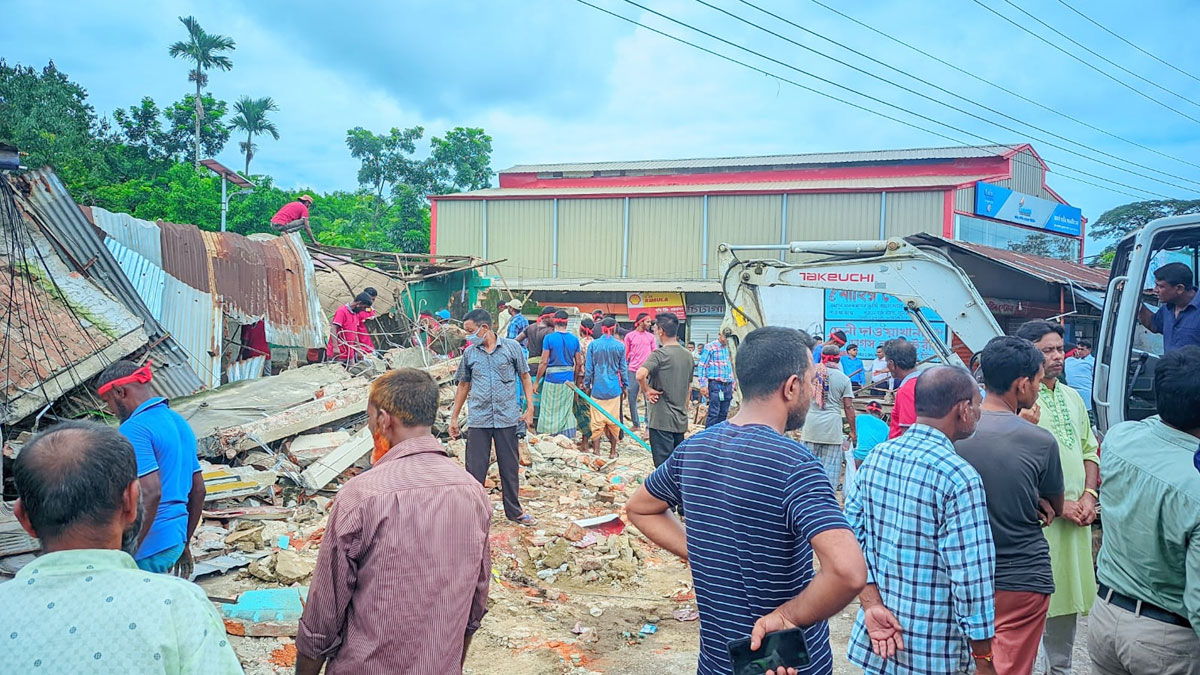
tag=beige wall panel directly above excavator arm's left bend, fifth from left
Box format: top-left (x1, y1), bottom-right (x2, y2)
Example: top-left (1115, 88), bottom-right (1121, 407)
top-left (708, 195), bottom-right (794, 279)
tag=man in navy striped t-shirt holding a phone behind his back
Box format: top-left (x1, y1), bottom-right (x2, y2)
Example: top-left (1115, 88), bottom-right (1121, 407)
top-left (626, 327), bottom-right (866, 675)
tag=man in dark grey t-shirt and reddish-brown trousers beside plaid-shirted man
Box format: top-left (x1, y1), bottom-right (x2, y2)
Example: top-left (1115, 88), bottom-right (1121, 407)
top-left (954, 335), bottom-right (1062, 675)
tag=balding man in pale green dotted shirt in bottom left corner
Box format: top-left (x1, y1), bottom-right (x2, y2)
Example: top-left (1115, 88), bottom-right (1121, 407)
top-left (0, 422), bottom-right (241, 674)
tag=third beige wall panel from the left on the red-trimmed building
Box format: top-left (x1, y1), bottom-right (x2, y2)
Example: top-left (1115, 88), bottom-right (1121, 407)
top-left (558, 199), bottom-right (625, 279)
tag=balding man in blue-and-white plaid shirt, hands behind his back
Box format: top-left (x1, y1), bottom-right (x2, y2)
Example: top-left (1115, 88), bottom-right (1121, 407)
top-left (846, 366), bottom-right (996, 675)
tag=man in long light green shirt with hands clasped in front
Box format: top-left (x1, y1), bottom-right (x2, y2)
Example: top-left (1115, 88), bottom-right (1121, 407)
top-left (1016, 319), bottom-right (1100, 675)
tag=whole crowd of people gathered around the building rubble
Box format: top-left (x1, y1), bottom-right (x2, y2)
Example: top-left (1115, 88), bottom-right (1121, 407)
top-left (0, 289), bottom-right (1200, 675)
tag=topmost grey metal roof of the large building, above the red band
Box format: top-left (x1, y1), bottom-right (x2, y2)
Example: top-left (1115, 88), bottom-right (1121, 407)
top-left (500, 143), bottom-right (1025, 173)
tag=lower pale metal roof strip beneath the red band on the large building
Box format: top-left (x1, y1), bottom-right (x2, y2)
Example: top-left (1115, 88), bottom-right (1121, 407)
top-left (433, 174), bottom-right (994, 199)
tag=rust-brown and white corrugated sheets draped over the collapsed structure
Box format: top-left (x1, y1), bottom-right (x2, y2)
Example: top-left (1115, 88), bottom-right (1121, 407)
top-left (85, 208), bottom-right (326, 348)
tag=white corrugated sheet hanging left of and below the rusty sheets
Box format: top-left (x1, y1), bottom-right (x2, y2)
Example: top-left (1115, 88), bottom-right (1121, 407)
top-left (158, 275), bottom-right (222, 388)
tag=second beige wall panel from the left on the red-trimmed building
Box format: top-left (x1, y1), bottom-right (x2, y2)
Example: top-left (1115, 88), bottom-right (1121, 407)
top-left (487, 199), bottom-right (552, 280)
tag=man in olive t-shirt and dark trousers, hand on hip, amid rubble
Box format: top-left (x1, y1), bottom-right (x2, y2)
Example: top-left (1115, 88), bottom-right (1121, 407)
top-left (635, 312), bottom-right (696, 466)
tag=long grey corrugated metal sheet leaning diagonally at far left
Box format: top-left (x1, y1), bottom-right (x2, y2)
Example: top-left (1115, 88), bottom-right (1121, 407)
top-left (7, 168), bottom-right (204, 398)
